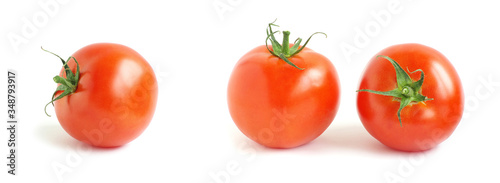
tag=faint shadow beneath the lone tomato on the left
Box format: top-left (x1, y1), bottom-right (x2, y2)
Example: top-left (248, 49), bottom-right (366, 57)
top-left (35, 121), bottom-right (125, 152)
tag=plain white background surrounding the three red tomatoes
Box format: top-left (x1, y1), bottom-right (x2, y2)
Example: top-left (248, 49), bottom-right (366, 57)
top-left (0, 0), bottom-right (500, 183)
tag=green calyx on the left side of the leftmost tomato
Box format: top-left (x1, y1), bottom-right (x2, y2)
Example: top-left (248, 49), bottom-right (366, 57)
top-left (42, 47), bottom-right (80, 117)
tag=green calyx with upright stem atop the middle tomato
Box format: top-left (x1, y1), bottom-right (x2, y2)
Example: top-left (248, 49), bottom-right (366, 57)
top-left (266, 20), bottom-right (327, 70)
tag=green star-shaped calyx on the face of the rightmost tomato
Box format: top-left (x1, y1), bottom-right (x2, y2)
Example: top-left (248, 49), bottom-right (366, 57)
top-left (356, 55), bottom-right (433, 126)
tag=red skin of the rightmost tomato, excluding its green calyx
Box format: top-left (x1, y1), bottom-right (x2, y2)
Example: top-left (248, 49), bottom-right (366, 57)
top-left (357, 43), bottom-right (464, 151)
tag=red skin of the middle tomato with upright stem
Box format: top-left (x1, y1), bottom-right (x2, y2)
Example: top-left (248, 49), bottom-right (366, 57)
top-left (228, 45), bottom-right (340, 148)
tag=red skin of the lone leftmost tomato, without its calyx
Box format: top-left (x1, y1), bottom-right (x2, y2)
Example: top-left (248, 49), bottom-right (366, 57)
top-left (54, 43), bottom-right (158, 147)
